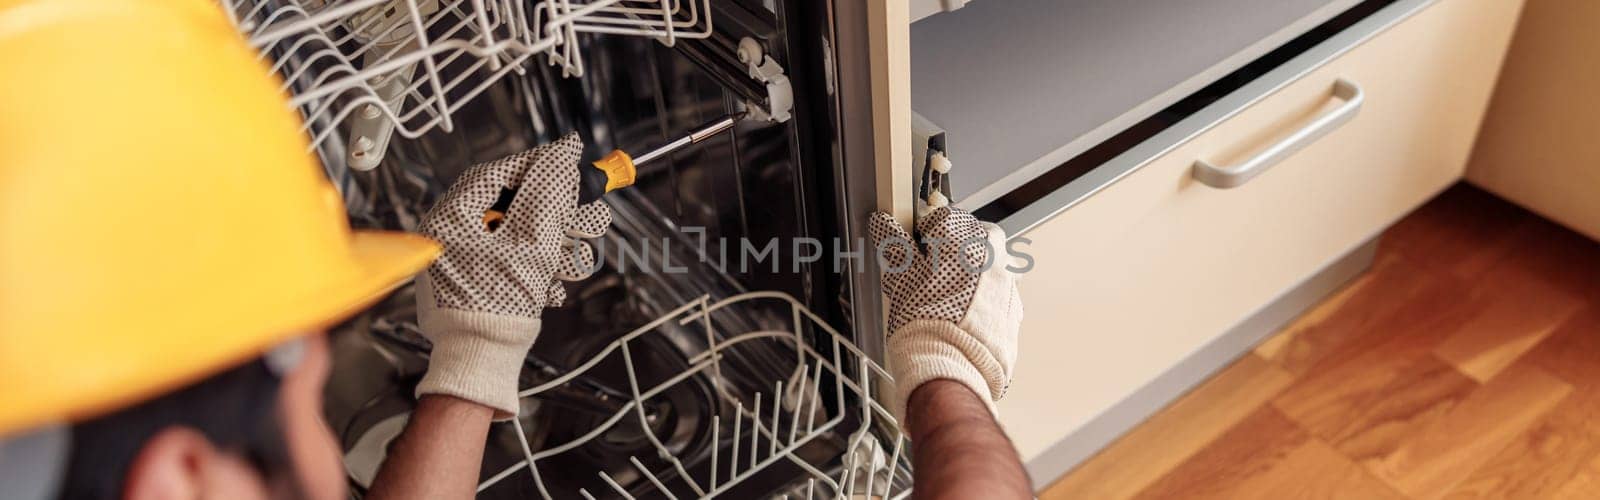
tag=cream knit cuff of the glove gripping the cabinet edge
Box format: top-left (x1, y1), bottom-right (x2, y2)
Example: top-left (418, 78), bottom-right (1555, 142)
top-left (888, 319), bottom-right (1005, 433)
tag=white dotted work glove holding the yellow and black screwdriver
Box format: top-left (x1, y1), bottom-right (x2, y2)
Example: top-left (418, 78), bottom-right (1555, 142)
top-left (416, 135), bottom-right (611, 418)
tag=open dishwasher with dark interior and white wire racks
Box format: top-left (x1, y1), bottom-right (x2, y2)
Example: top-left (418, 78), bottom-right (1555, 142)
top-left (221, 0), bottom-right (910, 498)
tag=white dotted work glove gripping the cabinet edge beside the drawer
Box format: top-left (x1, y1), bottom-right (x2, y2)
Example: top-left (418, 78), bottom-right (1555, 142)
top-left (869, 207), bottom-right (1022, 429)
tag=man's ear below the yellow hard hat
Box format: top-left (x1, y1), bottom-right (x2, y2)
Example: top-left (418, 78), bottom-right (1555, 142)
top-left (123, 426), bottom-right (218, 500)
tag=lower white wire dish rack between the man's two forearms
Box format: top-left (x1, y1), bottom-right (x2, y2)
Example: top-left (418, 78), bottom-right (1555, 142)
top-left (464, 292), bottom-right (912, 498)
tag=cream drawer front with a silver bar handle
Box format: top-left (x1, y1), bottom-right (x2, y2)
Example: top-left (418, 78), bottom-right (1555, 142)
top-left (1000, 0), bottom-right (1520, 460)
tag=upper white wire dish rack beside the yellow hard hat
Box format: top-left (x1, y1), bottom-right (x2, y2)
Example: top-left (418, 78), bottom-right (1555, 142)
top-left (221, 0), bottom-right (712, 170)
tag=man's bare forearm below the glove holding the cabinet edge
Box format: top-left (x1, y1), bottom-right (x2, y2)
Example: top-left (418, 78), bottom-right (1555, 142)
top-left (907, 380), bottom-right (1034, 498)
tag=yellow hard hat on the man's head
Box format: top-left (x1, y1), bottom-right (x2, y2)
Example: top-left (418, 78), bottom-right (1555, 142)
top-left (0, 0), bottom-right (438, 436)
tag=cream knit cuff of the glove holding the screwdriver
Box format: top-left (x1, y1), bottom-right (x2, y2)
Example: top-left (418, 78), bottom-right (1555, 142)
top-left (416, 309), bottom-right (539, 420)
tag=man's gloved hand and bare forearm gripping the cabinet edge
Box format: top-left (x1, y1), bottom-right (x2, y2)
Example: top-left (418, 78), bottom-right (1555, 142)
top-left (869, 207), bottom-right (1032, 498)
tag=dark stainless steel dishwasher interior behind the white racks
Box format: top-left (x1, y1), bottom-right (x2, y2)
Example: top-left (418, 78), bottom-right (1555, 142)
top-left (299, 5), bottom-right (883, 498)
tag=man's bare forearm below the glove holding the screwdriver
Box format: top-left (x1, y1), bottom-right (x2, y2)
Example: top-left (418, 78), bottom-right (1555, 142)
top-left (366, 394), bottom-right (494, 500)
